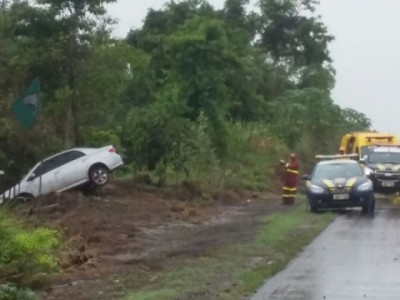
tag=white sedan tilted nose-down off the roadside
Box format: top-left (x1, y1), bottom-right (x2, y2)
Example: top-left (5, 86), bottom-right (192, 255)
top-left (0, 146), bottom-right (123, 204)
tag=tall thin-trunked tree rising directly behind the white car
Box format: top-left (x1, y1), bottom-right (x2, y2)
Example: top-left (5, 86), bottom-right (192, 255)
top-left (30, 0), bottom-right (115, 146)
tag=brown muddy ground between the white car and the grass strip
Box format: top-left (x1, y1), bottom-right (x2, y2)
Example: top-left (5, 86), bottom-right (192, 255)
top-left (11, 181), bottom-right (282, 300)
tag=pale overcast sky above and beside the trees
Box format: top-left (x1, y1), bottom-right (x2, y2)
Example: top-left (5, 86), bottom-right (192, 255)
top-left (108, 0), bottom-right (400, 135)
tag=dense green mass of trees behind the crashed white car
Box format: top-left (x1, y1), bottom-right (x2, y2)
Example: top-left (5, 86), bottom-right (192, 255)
top-left (0, 0), bottom-right (370, 188)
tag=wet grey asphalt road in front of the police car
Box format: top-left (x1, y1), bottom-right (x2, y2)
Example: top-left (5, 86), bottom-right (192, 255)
top-left (252, 201), bottom-right (400, 300)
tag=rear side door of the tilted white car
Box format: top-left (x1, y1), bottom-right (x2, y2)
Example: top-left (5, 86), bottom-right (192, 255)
top-left (54, 150), bottom-right (87, 190)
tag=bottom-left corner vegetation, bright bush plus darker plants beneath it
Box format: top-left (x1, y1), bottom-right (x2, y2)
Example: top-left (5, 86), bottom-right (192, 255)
top-left (0, 208), bottom-right (60, 300)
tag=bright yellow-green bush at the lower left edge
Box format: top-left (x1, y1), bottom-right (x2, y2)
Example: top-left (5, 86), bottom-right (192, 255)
top-left (0, 212), bottom-right (59, 282)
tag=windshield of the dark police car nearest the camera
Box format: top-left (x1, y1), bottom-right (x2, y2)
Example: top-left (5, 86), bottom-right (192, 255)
top-left (313, 163), bottom-right (364, 179)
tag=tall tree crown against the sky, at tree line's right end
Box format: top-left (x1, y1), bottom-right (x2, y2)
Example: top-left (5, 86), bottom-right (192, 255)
top-left (257, 0), bottom-right (333, 88)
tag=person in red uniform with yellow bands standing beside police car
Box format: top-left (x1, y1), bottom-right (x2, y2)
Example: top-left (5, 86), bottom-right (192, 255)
top-left (281, 153), bottom-right (299, 205)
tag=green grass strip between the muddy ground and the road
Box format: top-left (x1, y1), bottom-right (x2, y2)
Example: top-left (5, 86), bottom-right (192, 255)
top-left (124, 200), bottom-right (333, 300)
